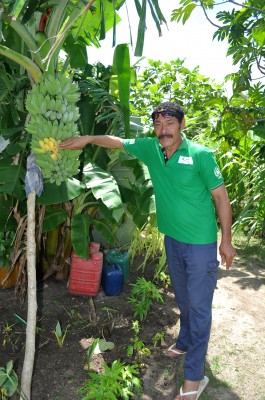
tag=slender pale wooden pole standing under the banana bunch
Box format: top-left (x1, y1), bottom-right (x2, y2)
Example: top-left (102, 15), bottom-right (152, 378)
top-left (20, 191), bottom-right (37, 400)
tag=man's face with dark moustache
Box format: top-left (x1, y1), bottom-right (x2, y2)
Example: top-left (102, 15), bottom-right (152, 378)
top-left (154, 113), bottom-right (185, 150)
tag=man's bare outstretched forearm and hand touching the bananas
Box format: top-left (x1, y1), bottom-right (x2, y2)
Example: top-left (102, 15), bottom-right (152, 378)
top-left (59, 135), bottom-right (123, 150)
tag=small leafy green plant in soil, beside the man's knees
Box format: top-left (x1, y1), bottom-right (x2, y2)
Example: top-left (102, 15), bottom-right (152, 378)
top-left (128, 277), bottom-right (164, 321)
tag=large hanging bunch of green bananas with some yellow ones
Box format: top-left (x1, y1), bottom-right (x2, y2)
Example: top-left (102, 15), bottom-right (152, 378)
top-left (26, 74), bottom-right (81, 186)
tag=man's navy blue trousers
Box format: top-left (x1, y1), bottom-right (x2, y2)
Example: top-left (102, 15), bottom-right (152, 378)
top-left (165, 236), bottom-right (219, 381)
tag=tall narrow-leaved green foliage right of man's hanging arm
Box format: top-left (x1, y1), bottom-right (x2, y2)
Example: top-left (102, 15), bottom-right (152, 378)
top-left (219, 138), bottom-right (265, 238)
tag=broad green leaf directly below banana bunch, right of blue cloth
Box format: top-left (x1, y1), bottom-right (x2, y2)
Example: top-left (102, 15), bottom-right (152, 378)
top-left (36, 178), bottom-right (85, 205)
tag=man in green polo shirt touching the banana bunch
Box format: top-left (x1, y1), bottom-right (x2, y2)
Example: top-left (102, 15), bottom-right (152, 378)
top-left (59, 102), bottom-right (236, 400)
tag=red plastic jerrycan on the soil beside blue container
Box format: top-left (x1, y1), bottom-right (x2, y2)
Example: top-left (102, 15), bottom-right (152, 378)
top-left (68, 242), bottom-right (103, 296)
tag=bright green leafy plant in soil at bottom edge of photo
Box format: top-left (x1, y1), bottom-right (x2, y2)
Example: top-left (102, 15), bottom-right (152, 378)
top-left (79, 360), bottom-right (142, 400)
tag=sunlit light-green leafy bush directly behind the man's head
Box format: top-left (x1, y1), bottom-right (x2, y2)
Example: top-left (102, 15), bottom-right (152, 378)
top-left (131, 59), bottom-right (223, 137)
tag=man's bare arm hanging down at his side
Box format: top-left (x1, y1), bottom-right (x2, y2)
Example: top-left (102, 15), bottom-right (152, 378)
top-left (211, 185), bottom-right (236, 269)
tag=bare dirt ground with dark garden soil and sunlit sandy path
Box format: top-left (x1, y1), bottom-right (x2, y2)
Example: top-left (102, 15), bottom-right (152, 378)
top-left (0, 244), bottom-right (265, 400)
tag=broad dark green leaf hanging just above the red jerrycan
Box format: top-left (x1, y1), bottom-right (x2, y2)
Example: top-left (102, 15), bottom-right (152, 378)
top-left (71, 214), bottom-right (91, 259)
